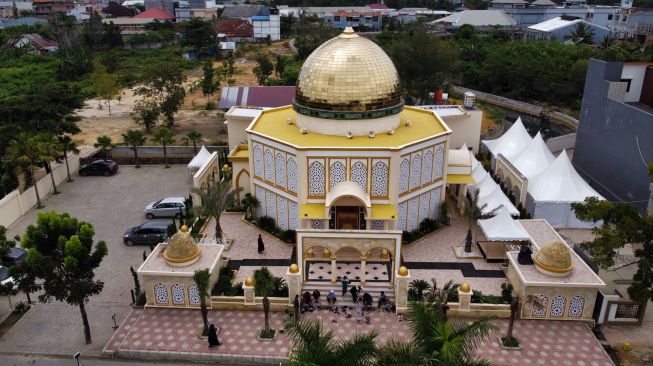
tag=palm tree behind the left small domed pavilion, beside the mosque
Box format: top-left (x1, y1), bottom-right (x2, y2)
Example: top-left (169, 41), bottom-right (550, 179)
top-left (192, 179), bottom-right (240, 240)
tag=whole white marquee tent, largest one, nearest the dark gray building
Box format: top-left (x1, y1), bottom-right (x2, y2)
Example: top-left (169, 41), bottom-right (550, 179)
top-left (526, 150), bottom-right (604, 228)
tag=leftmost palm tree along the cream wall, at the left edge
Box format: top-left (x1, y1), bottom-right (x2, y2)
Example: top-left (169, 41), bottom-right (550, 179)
top-left (7, 132), bottom-right (45, 208)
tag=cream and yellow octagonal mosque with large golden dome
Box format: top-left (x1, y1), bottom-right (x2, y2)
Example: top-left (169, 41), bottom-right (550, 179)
top-left (228, 28), bottom-right (480, 281)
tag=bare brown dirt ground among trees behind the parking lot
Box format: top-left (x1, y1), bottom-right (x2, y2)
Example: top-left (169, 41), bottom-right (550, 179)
top-left (74, 41), bottom-right (291, 145)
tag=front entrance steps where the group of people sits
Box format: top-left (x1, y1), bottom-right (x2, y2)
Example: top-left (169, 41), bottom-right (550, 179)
top-left (300, 281), bottom-right (395, 308)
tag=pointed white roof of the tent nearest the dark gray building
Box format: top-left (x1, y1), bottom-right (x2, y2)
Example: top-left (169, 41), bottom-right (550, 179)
top-left (528, 150), bottom-right (603, 202)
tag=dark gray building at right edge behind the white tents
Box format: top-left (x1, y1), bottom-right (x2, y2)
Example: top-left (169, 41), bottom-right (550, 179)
top-left (573, 59), bottom-right (653, 213)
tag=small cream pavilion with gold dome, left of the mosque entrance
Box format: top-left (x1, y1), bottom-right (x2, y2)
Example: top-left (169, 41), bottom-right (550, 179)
top-left (137, 225), bottom-right (224, 308)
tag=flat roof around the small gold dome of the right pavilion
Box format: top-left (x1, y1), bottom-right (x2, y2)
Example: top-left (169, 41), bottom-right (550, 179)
top-left (507, 219), bottom-right (605, 288)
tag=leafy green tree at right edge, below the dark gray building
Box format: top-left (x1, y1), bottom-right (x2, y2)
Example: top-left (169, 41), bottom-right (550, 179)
top-left (571, 197), bottom-right (653, 303)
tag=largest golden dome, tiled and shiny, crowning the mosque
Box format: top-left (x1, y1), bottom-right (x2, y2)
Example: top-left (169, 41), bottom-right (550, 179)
top-left (293, 27), bottom-right (403, 119)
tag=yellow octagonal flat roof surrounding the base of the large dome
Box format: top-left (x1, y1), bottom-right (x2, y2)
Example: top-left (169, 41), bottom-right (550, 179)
top-left (247, 106), bottom-right (451, 150)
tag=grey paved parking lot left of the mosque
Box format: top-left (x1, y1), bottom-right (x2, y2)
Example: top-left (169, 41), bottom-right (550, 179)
top-left (0, 166), bottom-right (190, 355)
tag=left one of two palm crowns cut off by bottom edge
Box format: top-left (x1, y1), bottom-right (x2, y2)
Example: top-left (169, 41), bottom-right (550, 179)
top-left (283, 318), bottom-right (379, 366)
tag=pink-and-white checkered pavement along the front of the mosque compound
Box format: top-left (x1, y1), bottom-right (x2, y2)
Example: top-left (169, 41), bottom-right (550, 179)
top-left (104, 308), bottom-right (613, 366)
